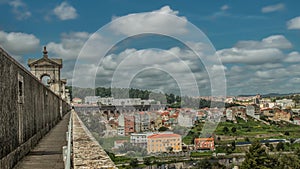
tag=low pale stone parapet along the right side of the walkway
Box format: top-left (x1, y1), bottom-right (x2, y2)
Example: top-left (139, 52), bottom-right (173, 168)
top-left (72, 112), bottom-right (117, 169)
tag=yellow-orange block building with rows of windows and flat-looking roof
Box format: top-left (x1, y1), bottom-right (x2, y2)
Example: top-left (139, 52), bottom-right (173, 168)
top-left (147, 133), bottom-right (182, 153)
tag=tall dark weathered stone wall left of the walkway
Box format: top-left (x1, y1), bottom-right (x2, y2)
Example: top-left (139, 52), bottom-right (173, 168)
top-left (0, 47), bottom-right (70, 169)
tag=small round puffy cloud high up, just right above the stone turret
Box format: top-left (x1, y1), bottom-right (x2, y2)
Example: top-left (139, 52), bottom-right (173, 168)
top-left (53, 2), bottom-right (78, 20)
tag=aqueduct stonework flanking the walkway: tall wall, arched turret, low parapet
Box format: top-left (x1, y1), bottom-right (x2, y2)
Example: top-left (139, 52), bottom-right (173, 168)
top-left (0, 47), bottom-right (116, 169)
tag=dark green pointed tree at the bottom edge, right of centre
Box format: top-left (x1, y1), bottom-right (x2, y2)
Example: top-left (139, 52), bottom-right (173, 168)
top-left (241, 141), bottom-right (271, 169)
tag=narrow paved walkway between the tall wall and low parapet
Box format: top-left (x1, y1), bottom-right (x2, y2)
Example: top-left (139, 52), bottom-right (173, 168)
top-left (15, 113), bottom-right (70, 169)
